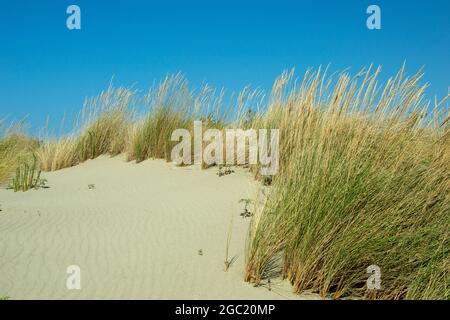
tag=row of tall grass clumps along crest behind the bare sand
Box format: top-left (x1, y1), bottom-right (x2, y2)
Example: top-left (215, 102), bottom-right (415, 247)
top-left (36, 74), bottom-right (248, 170)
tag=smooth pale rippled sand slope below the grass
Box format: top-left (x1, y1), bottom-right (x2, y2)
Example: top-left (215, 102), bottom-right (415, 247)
top-left (0, 157), bottom-right (316, 299)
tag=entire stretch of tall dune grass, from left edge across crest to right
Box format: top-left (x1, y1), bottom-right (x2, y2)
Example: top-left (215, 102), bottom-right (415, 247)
top-left (0, 68), bottom-right (450, 299)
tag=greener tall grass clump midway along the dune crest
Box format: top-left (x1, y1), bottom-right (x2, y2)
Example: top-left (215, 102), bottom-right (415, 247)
top-left (127, 74), bottom-right (248, 162)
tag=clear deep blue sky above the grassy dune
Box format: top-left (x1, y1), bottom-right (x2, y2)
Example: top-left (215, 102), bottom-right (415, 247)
top-left (0, 0), bottom-right (450, 132)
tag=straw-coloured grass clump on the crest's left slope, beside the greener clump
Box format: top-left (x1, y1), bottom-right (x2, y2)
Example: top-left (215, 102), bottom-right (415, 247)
top-left (36, 85), bottom-right (135, 171)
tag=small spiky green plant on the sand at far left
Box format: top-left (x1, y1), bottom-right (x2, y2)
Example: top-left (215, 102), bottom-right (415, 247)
top-left (8, 155), bottom-right (47, 192)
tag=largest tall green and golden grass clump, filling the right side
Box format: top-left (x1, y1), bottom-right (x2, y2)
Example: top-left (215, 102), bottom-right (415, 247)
top-left (245, 65), bottom-right (450, 299)
